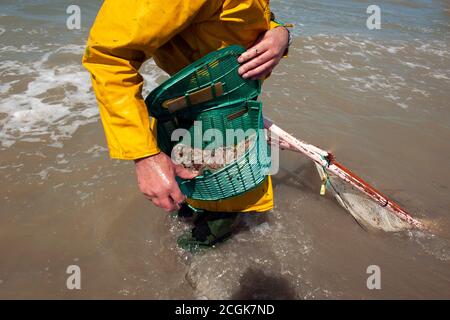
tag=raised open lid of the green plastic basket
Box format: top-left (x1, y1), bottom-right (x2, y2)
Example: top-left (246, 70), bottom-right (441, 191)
top-left (145, 45), bottom-right (261, 122)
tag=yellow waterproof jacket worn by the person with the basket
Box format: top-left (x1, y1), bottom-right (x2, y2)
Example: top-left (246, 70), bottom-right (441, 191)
top-left (83, 0), bottom-right (277, 212)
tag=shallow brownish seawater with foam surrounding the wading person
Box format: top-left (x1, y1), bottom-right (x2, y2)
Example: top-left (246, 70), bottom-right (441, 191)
top-left (0, 0), bottom-right (450, 299)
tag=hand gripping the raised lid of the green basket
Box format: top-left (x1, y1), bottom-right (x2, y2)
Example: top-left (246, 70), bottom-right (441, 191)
top-left (238, 27), bottom-right (289, 79)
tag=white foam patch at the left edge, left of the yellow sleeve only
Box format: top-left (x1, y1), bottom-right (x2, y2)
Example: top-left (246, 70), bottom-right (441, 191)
top-left (0, 48), bottom-right (98, 147)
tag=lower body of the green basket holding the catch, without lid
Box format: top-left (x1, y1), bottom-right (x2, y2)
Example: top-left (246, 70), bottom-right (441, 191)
top-left (178, 101), bottom-right (271, 200)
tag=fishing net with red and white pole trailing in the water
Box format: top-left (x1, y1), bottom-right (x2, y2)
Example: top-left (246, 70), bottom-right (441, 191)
top-left (264, 118), bottom-right (423, 232)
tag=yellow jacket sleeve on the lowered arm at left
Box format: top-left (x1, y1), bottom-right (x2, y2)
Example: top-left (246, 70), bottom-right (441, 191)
top-left (83, 0), bottom-right (207, 159)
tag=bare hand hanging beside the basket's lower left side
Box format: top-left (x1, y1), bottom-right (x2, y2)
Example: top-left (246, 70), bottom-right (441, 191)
top-left (135, 152), bottom-right (198, 212)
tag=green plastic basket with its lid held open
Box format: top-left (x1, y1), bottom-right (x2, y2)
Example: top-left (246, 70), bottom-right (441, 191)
top-left (146, 46), bottom-right (270, 200)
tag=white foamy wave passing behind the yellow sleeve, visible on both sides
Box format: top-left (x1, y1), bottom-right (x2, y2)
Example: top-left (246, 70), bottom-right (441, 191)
top-left (0, 45), bottom-right (162, 148)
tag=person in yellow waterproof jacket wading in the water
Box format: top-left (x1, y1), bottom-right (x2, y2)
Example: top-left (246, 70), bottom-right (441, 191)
top-left (83, 0), bottom-right (289, 249)
